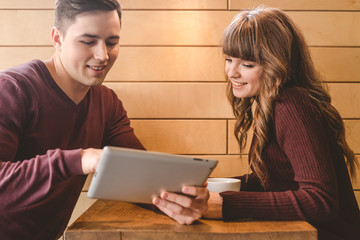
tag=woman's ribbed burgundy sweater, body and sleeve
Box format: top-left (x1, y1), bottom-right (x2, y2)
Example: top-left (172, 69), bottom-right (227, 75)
top-left (221, 88), bottom-right (360, 240)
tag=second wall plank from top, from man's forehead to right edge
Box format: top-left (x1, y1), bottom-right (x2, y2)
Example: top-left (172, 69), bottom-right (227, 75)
top-left (122, 11), bottom-right (360, 46)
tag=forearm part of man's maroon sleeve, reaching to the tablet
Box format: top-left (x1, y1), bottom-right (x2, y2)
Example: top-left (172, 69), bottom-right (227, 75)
top-left (0, 149), bottom-right (83, 212)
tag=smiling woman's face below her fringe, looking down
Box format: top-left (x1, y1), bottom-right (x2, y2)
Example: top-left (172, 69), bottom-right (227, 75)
top-left (225, 56), bottom-right (263, 98)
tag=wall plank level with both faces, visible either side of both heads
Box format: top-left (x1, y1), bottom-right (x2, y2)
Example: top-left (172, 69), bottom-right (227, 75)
top-left (0, 46), bottom-right (360, 82)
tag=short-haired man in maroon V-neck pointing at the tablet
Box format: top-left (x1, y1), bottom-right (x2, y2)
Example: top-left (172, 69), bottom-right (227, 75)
top-left (0, 0), bottom-right (209, 240)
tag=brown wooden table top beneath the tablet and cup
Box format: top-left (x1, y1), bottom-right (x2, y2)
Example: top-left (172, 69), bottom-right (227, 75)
top-left (65, 200), bottom-right (317, 240)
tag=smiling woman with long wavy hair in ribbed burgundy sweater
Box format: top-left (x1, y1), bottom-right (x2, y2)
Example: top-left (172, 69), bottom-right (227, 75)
top-left (204, 8), bottom-right (360, 239)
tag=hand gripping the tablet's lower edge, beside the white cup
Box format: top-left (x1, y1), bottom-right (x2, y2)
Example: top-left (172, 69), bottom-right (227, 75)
top-left (153, 186), bottom-right (209, 224)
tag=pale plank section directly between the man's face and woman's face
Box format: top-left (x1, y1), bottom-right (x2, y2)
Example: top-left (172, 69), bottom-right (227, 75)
top-left (107, 46), bottom-right (225, 81)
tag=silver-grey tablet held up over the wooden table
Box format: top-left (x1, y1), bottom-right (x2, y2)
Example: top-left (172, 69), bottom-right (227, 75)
top-left (87, 146), bottom-right (218, 203)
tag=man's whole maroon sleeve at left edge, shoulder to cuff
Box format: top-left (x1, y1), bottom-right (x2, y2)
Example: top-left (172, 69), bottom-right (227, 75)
top-left (0, 76), bottom-right (83, 211)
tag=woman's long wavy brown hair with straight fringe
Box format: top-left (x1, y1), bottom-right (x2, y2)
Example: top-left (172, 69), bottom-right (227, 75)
top-left (223, 8), bottom-right (357, 188)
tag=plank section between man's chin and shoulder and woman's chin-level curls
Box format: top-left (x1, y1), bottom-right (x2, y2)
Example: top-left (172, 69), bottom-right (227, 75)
top-left (105, 82), bottom-right (232, 118)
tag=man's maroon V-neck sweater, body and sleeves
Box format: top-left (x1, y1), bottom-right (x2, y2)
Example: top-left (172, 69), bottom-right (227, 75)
top-left (0, 60), bottom-right (143, 240)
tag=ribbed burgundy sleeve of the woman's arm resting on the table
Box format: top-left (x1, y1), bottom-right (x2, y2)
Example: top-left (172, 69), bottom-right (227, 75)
top-left (221, 88), bottom-right (338, 222)
